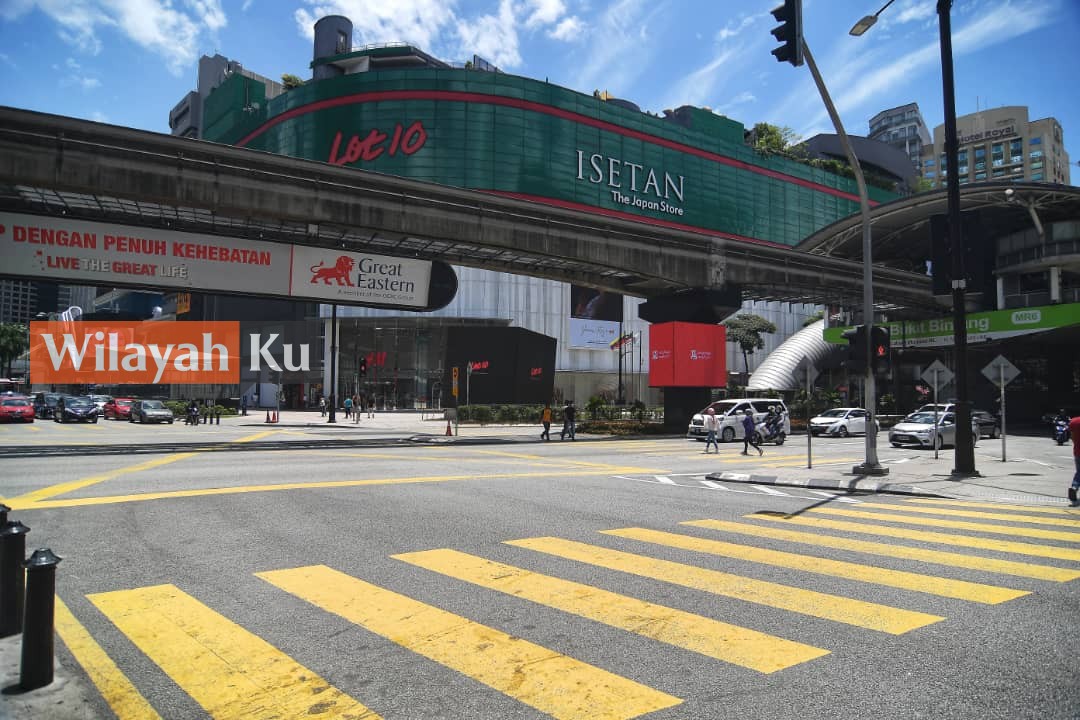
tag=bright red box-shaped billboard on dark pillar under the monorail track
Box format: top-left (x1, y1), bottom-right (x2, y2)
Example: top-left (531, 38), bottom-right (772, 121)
top-left (649, 323), bottom-right (728, 388)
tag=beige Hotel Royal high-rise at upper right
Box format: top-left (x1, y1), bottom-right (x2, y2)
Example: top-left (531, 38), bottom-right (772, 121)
top-left (922, 105), bottom-right (1069, 188)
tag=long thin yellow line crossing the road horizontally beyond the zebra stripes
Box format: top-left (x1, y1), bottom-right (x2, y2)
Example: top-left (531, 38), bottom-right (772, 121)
top-left (4, 467), bottom-right (656, 511)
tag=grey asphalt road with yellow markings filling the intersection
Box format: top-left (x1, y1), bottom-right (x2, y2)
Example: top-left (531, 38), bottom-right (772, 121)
top-left (0, 426), bottom-right (1080, 720)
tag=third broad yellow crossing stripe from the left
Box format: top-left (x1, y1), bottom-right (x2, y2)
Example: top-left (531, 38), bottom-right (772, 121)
top-left (392, 549), bottom-right (828, 673)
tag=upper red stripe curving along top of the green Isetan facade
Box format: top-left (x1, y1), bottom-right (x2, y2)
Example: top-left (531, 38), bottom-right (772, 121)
top-left (237, 90), bottom-right (878, 206)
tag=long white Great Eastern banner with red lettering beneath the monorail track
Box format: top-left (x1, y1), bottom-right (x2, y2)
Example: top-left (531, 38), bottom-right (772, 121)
top-left (0, 213), bottom-right (436, 310)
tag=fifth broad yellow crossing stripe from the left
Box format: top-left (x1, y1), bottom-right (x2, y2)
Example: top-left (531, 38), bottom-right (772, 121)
top-left (602, 528), bottom-right (1030, 604)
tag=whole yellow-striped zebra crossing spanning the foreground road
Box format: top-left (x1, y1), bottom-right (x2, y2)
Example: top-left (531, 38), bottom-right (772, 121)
top-left (57, 499), bottom-right (1080, 720)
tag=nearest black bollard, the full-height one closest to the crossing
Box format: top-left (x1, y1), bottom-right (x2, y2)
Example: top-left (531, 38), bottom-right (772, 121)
top-left (18, 547), bottom-right (60, 690)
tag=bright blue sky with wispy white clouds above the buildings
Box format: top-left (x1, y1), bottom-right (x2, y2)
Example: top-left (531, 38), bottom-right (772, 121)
top-left (0, 0), bottom-right (1080, 178)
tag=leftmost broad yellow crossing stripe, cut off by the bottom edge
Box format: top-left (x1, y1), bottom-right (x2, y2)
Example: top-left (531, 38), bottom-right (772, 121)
top-left (87, 585), bottom-right (379, 720)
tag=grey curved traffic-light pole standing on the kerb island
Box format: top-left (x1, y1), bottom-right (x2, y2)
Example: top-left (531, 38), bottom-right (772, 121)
top-left (800, 38), bottom-right (889, 475)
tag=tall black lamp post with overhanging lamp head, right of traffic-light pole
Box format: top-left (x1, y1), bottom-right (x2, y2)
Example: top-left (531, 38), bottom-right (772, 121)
top-left (851, 0), bottom-right (978, 478)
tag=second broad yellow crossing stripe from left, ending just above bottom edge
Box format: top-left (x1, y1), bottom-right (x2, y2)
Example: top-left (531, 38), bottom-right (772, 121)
top-left (255, 566), bottom-right (683, 720)
